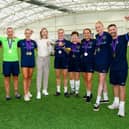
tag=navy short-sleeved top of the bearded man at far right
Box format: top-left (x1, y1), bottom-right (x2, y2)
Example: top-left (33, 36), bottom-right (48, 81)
top-left (110, 34), bottom-right (129, 71)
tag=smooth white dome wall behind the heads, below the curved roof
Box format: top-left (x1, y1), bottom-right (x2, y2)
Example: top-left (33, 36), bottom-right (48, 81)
top-left (3, 10), bottom-right (129, 39)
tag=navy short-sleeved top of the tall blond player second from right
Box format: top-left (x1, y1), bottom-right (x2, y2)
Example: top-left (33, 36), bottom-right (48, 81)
top-left (95, 32), bottom-right (112, 65)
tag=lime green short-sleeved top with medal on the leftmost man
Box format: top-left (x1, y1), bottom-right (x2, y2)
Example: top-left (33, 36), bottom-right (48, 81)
top-left (0, 37), bottom-right (19, 62)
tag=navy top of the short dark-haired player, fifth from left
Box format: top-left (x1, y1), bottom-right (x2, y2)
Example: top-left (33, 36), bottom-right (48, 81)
top-left (69, 43), bottom-right (81, 61)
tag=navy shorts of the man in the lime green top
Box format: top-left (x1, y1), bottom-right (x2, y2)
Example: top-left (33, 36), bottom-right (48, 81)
top-left (3, 61), bottom-right (20, 76)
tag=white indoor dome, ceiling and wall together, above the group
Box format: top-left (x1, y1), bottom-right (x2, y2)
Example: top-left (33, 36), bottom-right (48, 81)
top-left (0, 0), bottom-right (129, 38)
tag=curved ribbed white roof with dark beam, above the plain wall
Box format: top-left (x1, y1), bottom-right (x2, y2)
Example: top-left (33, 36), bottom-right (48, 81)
top-left (0, 0), bottom-right (129, 28)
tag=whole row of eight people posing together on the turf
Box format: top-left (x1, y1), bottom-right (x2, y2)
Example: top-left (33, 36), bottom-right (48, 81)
top-left (0, 21), bottom-right (129, 117)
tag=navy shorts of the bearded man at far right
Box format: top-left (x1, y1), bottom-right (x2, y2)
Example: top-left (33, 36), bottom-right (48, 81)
top-left (109, 70), bottom-right (128, 86)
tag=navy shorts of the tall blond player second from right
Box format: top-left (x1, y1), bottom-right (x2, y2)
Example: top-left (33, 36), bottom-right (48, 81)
top-left (94, 64), bottom-right (109, 73)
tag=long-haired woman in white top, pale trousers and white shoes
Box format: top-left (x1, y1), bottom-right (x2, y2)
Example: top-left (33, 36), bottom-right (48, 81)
top-left (36, 28), bottom-right (50, 99)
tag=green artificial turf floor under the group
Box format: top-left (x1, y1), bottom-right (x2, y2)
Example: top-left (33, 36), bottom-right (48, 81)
top-left (0, 51), bottom-right (129, 129)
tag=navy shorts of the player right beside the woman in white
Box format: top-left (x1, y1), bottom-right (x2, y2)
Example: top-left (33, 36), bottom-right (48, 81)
top-left (54, 57), bottom-right (68, 69)
